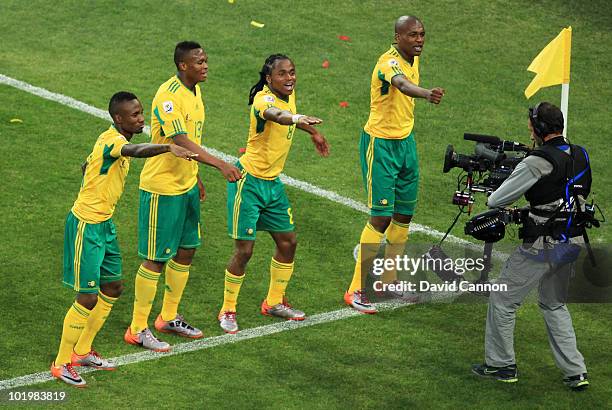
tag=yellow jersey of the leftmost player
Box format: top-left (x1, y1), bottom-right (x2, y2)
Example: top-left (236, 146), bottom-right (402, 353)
top-left (72, 125), bottom-right (130, 223)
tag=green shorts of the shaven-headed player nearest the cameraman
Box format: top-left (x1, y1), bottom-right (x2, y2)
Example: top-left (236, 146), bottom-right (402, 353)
top-left (359, 131), bottom-right (419, 216)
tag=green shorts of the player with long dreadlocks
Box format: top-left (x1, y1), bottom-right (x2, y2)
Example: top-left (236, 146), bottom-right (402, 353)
top-left (227, 163), bottom-right (294, 241)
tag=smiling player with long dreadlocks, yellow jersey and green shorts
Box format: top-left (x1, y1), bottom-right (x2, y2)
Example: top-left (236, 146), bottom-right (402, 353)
top-left (218, 54), bottom-right (329, 333)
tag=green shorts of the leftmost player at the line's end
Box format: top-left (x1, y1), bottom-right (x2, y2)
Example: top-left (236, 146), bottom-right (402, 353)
top-left (63, 211), bottom-right (121, 293)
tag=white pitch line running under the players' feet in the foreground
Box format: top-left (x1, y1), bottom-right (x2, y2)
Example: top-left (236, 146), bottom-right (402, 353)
top-left (0, 302), bottom-right (411, 391)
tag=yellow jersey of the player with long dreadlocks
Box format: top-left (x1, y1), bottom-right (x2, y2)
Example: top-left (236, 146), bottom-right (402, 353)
top-left (240, 86), bottom-right (296, 180)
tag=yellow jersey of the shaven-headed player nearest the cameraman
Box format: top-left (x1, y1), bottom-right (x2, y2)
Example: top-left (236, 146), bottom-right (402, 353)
top-left (364, 46), bottom-right (419, 139)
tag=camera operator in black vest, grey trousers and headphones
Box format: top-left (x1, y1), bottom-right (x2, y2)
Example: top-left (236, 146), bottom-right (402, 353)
top-left (472, 102), bottom-right (591, 390)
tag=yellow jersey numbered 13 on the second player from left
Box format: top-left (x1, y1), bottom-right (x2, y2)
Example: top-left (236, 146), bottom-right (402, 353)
top-left (140, 75), bottom-right (204, 195)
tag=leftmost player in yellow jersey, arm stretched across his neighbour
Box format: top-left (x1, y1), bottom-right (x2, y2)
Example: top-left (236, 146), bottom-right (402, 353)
top-left (51, 91), bottom-right (196, 387)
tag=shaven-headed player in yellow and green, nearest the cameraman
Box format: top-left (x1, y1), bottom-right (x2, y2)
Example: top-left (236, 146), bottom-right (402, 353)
top-left (344, 16), bottom-right (444, 313)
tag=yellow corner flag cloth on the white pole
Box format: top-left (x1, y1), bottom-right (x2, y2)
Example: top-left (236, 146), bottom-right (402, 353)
top-left (525, 26), bottom-right (572, 98)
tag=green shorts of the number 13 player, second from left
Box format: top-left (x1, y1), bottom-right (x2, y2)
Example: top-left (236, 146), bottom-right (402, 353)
top-left (138, 184), bottom-right (201, 262)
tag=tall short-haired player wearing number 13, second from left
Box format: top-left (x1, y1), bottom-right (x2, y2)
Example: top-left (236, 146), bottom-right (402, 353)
top-left (124, 41), bottom-right (242, 351)
